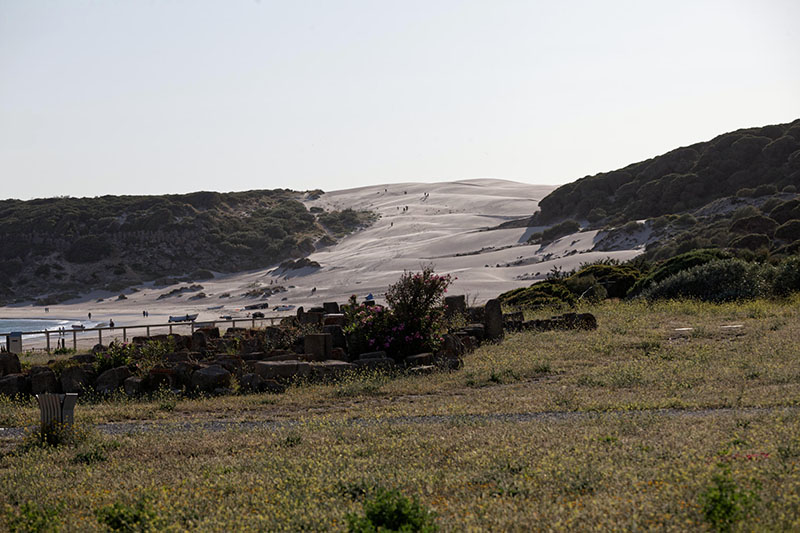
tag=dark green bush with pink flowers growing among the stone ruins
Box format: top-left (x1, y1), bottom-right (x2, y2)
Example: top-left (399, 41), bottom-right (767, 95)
top-left (344, 267), bottom-right (452, 358)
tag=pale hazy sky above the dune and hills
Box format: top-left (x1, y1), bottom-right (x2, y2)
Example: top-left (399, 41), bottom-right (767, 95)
top-left (0, 0), bottom-right (800, 198)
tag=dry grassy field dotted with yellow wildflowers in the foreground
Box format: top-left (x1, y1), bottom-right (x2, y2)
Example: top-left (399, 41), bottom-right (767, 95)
top-left (0, 299), bottom-right (800, 531)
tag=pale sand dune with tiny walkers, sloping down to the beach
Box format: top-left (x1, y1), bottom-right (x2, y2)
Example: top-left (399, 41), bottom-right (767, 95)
top-left (0, 179), bottom-right (643, 336)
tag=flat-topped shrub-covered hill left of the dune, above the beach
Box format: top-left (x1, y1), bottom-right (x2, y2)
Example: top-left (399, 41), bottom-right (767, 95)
top-left (0, 189), bottom-right (371, 304)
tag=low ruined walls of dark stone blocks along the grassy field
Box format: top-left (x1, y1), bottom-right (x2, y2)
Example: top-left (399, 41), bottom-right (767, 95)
top-left (0, 296), bottom-right (597, 396)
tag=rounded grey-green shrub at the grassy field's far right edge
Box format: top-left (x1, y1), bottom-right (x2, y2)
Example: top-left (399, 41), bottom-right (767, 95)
top-left (642, 259), bottom-right (771, 302)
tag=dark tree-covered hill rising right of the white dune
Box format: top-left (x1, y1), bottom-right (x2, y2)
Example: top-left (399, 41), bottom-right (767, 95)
top-left (532, 119), bottom-right (800, 225)
